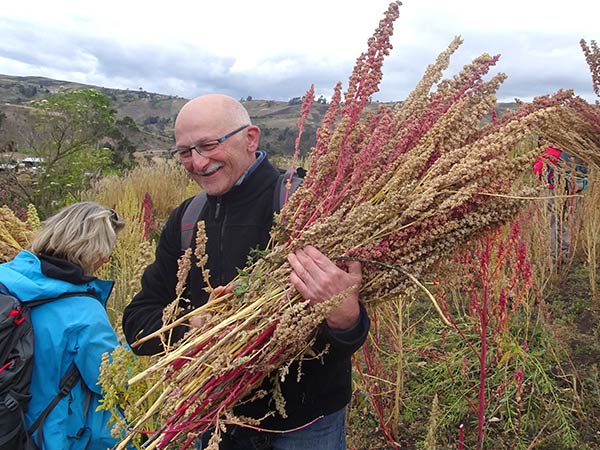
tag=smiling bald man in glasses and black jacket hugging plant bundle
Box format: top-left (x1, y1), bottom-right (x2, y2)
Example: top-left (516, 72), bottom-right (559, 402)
top-left (123, 94), bottom-right (369, 450)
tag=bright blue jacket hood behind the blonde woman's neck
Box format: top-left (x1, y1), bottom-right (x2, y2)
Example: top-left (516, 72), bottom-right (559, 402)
top-left (0, 250), bottom-right (114, 305)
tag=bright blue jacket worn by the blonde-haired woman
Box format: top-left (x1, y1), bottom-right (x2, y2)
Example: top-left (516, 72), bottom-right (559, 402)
top-left (0, 251), bottom-right (119, 450)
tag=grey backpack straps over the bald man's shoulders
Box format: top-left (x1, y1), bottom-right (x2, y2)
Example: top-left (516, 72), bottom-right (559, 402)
top-left (179, 167), bottom-right (306, 251)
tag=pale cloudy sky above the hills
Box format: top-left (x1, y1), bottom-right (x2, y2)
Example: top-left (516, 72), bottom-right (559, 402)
top-left (0, 0), bottom-right (600, 101)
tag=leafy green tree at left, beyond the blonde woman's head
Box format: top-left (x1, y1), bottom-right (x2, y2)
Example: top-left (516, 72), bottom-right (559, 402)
top-left (5, 89), bottom-right (116, 216)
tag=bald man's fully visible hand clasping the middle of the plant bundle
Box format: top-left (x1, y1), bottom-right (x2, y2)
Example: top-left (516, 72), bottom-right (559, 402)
top-left (288, 245), bottom-right (362, 330)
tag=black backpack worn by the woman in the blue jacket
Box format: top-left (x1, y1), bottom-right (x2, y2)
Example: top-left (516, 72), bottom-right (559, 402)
top-left (0, 285), bottom-right (91, 450)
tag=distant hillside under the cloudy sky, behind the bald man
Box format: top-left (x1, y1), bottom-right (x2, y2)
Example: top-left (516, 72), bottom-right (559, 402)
top-left (0, 75), bottom-right (515, 158)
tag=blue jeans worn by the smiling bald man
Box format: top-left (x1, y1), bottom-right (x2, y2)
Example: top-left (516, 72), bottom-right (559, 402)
top-left (199, 408), bottom-right (346, 450)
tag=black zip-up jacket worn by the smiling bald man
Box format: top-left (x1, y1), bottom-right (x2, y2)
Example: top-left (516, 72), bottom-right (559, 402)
top-left (123, 156), bottom-right (369, 430)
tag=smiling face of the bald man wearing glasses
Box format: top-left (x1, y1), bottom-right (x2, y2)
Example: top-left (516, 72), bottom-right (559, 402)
top-left (176, 123), bottom-right (258, 195)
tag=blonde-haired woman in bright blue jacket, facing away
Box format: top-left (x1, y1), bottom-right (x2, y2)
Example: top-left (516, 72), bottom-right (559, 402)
top-left (0, 202), bottom-right (124, 450)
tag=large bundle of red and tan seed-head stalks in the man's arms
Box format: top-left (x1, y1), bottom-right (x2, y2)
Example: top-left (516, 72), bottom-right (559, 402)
top-left (106, 1), bottom-right (600, 449)
